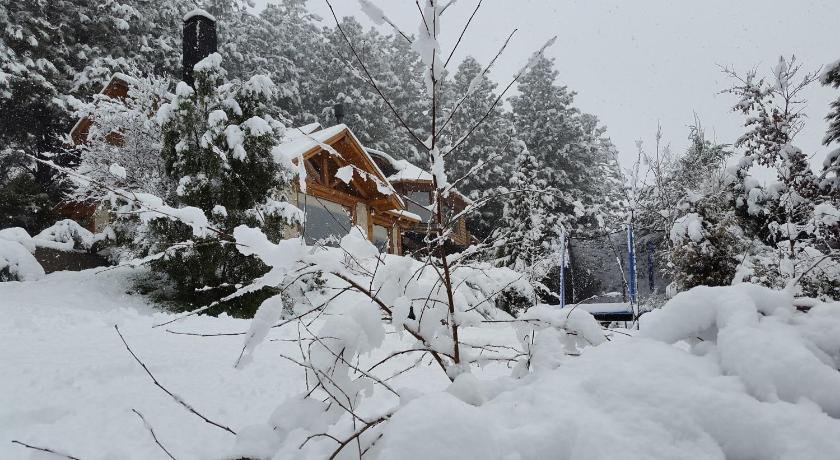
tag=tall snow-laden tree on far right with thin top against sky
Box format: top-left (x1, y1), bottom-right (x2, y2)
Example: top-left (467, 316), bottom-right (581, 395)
top-left (727, 57), bottom-right (840, 297)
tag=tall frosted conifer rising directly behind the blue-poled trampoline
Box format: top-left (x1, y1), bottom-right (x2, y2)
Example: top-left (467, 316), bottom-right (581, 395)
top-left (497, 54), bottom-right (622, 292)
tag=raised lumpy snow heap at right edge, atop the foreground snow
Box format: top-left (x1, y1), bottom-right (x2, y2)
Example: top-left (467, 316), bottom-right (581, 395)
top-left (641, 284), bottom-right (840, 417)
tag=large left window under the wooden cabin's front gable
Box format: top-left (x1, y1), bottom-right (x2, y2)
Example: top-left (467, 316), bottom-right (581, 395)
top-left (298, 193), bottom-right (353, 247)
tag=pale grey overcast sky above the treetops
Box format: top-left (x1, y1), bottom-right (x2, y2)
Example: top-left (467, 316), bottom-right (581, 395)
top-left (256, 0), bottom-right (840, 169)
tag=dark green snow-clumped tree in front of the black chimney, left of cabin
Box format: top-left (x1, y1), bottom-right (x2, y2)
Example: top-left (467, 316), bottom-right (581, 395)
top-left (130, 53), bottom-right (298, 314)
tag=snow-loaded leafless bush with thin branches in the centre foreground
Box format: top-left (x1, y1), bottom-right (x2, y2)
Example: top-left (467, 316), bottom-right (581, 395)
top-left (220, 222), bottom-right (606, 458)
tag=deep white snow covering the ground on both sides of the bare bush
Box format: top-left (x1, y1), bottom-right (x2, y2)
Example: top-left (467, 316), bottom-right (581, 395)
top-left (0, 268), bottom-right (840, 460)
